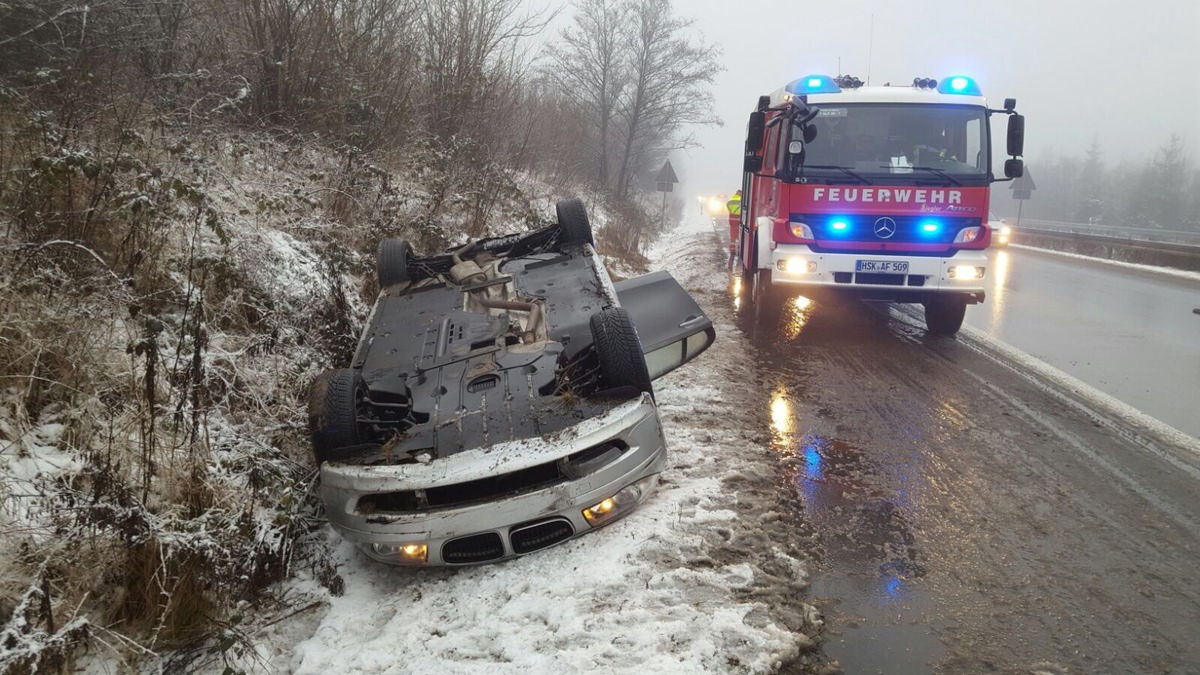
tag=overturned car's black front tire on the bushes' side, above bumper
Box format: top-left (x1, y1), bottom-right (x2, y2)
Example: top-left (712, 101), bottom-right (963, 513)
top-left (308, 368), bottom-right (362, 466)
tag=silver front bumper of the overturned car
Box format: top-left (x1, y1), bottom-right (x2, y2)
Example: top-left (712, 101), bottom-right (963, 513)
top-left (320, 394), bottom-right (666, 566)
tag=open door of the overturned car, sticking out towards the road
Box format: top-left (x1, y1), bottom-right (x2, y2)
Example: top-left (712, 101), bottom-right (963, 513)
top-left (613, 271), bottom-right (716, 380)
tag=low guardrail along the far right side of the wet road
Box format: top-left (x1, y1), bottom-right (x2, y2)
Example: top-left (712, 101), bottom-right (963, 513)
top-left (1013, 221), bottom-right (1200, 271)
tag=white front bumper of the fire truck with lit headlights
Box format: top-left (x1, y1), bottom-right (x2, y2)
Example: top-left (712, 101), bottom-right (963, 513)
top-left (769, 244), bottom-right (989, 303)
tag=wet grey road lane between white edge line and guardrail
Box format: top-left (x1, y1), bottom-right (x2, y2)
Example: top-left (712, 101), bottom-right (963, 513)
top-left (966, 247), bottom-right (1200, 437)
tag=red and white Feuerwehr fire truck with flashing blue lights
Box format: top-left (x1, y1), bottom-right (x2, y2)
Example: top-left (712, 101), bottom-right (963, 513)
top-left (738, 74), bottom-right (1025, 335)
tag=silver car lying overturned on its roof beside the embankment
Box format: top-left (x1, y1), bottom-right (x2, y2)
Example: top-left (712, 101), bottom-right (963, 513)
top-left (308, 199), bottom-right (715, 566)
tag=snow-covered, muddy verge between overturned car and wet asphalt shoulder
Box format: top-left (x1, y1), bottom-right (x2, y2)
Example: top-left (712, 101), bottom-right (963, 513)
top-left (247, 222), bottom-right (820, 674)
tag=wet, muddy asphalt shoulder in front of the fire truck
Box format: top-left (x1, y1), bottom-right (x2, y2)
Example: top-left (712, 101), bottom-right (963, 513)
top-left (731, 276), bottom-right (1200, 674)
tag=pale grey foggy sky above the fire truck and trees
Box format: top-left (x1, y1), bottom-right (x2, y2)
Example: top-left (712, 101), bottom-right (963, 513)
top-left (529, 0), bottom-right (1200, 199)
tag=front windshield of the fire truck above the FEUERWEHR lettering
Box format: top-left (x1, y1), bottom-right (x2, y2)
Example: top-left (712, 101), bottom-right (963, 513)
top-left (792, 103), bottom-right (991, 183)
